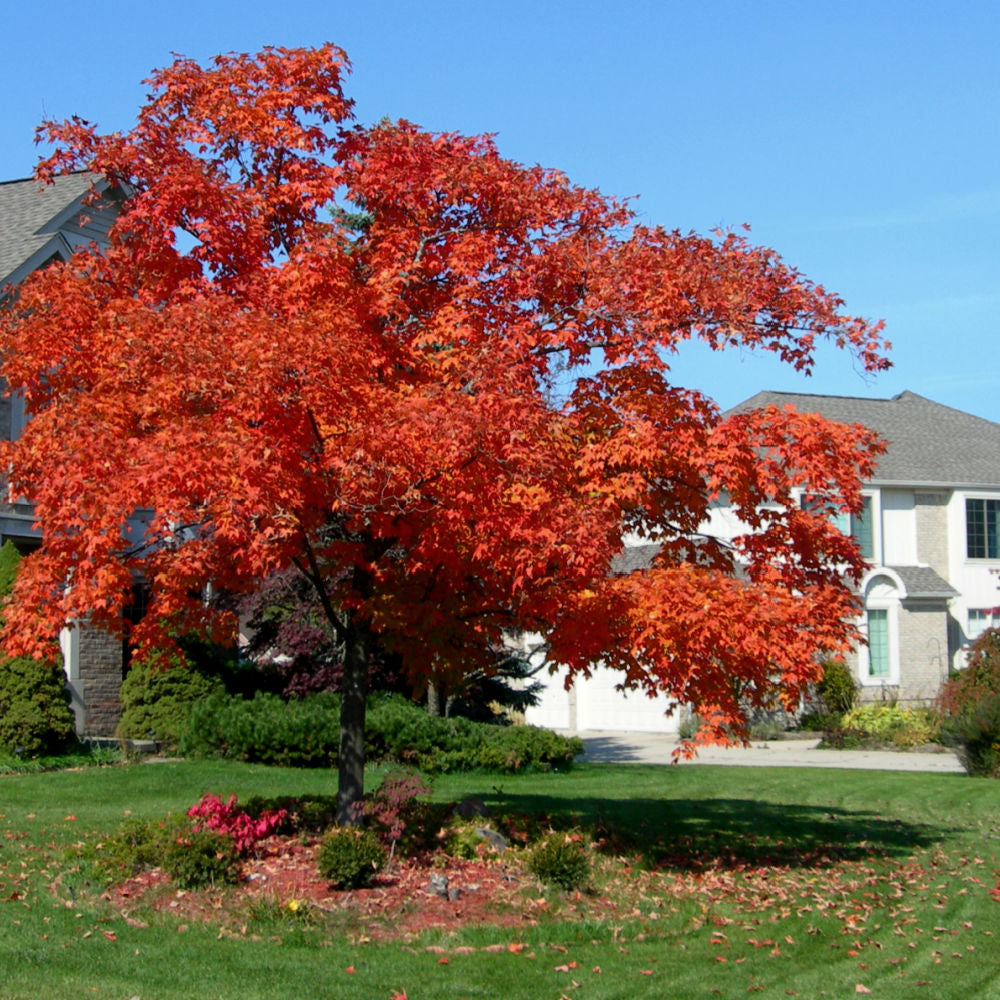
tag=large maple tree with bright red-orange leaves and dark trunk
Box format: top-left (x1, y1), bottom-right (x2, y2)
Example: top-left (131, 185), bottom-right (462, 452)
top-left (0, 45), bottom-right (888, 816)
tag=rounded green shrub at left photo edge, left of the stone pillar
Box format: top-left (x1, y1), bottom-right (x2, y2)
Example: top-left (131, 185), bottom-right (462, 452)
top-left (0, 657), bottom-right (76, 757)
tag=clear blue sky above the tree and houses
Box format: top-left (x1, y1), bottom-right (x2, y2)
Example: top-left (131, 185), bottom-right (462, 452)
top-left (0, 0), bottom-right (1000, 421)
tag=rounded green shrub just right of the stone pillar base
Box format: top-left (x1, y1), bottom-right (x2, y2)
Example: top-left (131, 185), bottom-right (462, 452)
top-left (117, 657), bottom-right (222, 751)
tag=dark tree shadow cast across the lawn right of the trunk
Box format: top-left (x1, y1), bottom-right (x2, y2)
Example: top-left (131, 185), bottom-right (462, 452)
top-left (483, 789), bottom-right (952, 870)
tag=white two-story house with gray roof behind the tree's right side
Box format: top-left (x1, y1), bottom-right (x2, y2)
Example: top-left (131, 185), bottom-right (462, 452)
top-left (527, 392), bottom-right (1000, 732)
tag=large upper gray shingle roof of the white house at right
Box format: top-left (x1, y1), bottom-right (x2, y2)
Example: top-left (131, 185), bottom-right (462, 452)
top-left (731, 392), bottom-right (1000, 487)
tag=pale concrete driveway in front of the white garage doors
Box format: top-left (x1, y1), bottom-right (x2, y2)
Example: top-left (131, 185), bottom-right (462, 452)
top-left (570, 730), bottom-right (963, 774)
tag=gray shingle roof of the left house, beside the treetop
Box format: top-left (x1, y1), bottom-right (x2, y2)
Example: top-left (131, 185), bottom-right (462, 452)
top-left (0, 173), bottom-right (100, 288)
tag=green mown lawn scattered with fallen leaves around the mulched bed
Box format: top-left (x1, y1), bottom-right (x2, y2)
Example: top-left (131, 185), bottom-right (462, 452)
top-left (0, 762), bottom-right (1000, 1000)
